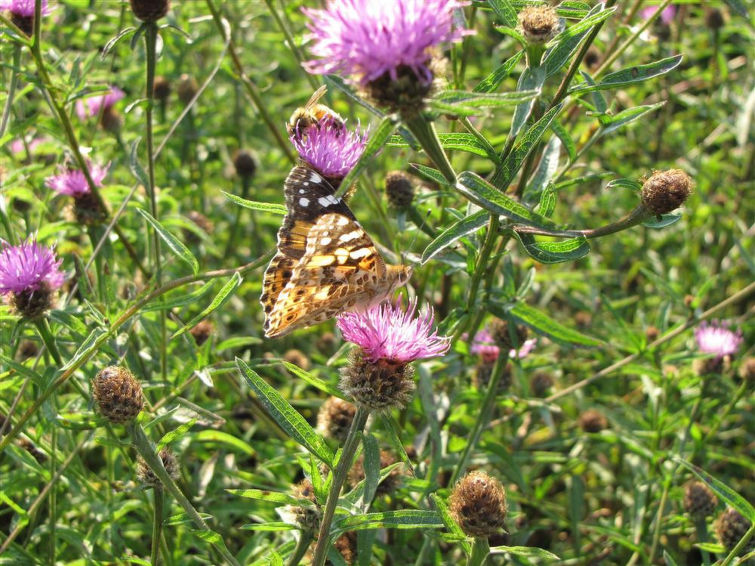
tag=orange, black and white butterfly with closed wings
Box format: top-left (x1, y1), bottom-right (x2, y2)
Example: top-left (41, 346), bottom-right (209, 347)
top-left (260, 165), bottom-right (411, 338)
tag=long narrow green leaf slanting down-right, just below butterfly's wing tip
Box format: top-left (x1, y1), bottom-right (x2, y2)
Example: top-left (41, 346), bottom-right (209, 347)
top-left (236, 358), bottom-right (333, 466)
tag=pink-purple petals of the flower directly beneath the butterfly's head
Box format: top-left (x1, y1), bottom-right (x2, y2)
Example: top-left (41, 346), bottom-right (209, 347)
top-left (337, 299), bottom-right (450, 364)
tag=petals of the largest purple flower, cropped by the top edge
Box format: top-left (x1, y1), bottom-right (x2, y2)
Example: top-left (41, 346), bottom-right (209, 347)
top-left (303, 0), bottom-right (473, 85)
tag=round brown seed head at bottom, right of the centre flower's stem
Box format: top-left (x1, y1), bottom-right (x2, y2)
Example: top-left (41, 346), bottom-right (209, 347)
top-left (448, 471), bottom-right (507, 537)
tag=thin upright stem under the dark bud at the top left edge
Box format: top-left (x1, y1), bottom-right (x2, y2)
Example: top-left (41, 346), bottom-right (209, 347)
top-left (144, 22), bottom-right (168, 381)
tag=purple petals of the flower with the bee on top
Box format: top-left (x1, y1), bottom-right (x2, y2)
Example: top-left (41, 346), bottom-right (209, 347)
top-left (290, 118), bottom-right (367, 179)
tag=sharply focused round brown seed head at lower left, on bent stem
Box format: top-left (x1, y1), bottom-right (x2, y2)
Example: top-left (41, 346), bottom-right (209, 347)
top-left (92, 366), bottom-right (144, 424)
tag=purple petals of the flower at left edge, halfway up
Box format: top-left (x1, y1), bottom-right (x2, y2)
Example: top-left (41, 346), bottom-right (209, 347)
top-left (0, 241), bottom-right (63, 295)
